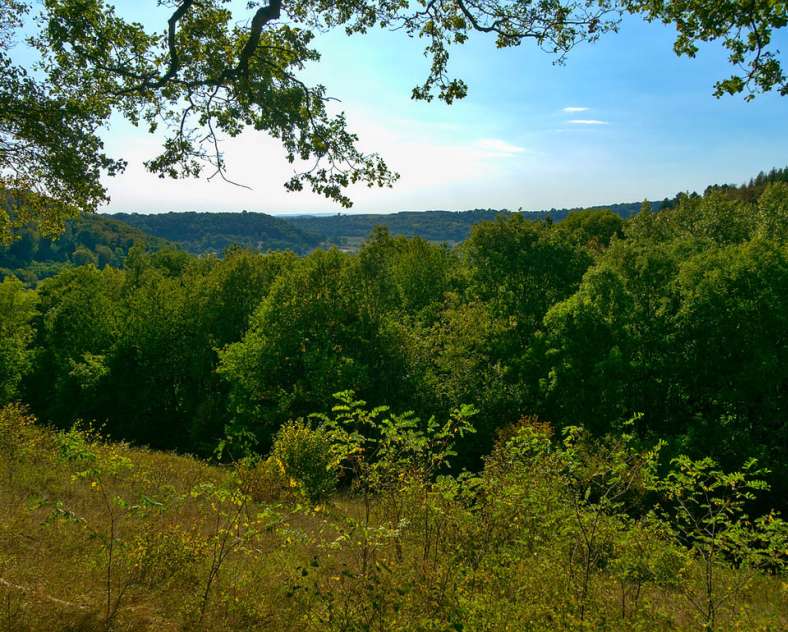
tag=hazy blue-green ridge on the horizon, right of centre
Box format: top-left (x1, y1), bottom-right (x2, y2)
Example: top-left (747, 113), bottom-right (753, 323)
top-left (285, 202), bottom-right (662, 246)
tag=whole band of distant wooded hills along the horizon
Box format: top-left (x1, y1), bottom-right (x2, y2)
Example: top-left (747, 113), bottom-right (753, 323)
top-left (7, 169), bottom-right (788, 287)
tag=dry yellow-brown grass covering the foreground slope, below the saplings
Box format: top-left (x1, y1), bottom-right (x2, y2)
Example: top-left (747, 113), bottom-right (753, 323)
top-left (0, 409), bottom-right (788, 632)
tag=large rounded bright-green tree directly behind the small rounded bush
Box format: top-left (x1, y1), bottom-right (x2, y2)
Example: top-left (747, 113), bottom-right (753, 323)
top-left (219, 250), bottom-right (410, 447)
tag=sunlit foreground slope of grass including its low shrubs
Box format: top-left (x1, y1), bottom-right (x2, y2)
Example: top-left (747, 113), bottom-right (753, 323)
top-left (0, 406), bottom-right (788, 632)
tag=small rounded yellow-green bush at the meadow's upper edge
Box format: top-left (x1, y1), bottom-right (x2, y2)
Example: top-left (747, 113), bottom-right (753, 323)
top-left (271, 420), bottom-right (337, 502)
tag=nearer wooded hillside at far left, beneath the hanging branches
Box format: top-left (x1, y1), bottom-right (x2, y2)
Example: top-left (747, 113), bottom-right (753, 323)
top-left (0, 215), bottom-right (168, 285)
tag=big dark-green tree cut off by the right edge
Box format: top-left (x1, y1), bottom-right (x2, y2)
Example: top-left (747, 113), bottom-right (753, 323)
top-left (671, 240), bottom-right (788, 486)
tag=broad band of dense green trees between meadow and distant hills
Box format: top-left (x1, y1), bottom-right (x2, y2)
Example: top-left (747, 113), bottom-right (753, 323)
top-left (0, 182), bottom-right (788, 502)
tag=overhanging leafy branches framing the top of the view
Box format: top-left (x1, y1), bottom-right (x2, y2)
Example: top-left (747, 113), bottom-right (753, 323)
top-left (0, 0), bottom-right (788, 239)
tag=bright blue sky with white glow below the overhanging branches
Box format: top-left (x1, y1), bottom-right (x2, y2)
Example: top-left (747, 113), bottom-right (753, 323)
top-left (86, 0), bottom-right (788, 212)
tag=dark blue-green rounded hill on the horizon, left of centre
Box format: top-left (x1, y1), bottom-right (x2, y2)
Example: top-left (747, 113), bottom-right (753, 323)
top-left (112, 211), bottom-right (322, 254)
